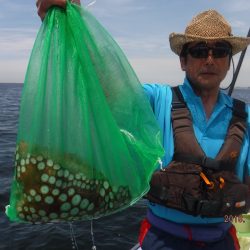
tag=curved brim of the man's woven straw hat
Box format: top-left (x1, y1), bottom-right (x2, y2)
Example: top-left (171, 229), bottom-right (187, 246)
top-left (169, 33), bottom-right (250, 55)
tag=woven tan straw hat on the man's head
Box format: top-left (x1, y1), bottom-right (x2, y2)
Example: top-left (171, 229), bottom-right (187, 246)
top-left (169, 10), bottom-right (250, 55)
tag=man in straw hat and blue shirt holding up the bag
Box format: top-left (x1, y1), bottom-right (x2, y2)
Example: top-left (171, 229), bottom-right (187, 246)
top-left (37, 0), bottom-right (250, 250)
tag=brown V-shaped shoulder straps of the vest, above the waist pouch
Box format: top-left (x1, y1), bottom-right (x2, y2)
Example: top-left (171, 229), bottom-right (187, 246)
top-left (172, 86), bottom-right (247, 171)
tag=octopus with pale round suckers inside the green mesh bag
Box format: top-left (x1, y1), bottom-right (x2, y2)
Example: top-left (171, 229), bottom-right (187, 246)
top-left (15, 142), bottom-right (131, 223)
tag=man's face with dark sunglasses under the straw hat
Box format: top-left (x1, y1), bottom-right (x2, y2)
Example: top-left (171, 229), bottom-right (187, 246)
top-left (180, 41), bottom-right (230, 90)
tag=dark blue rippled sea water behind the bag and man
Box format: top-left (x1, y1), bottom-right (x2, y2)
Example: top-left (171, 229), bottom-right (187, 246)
top-left (0, 84), bottom-right (250, 250)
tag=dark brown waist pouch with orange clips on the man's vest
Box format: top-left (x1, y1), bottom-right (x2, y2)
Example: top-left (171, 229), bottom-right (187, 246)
top-left (147, 162), bottom-right (248, 217)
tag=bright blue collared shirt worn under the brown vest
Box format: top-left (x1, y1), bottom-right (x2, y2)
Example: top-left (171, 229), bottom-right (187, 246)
top-left (143, 79), bottom-right (250, 224)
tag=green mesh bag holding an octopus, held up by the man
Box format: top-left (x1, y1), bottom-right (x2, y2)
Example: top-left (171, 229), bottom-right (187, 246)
top-left (6, 0), bottom-right (163, 223)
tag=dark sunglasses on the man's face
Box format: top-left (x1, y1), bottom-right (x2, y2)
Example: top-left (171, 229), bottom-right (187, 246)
top-left (187, 45), bottom-right (231, 58)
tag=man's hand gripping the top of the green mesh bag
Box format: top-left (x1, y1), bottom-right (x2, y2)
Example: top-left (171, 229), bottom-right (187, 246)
top-left (36, 0), bottom-right (81, 20)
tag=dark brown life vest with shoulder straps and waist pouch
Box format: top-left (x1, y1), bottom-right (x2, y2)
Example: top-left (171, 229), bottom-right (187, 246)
top-left (147, 87), bottom-right (248, 217)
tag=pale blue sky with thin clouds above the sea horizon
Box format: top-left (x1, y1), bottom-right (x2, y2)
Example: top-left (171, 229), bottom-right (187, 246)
top-left (0, 0), bottom-right (250, 87)
